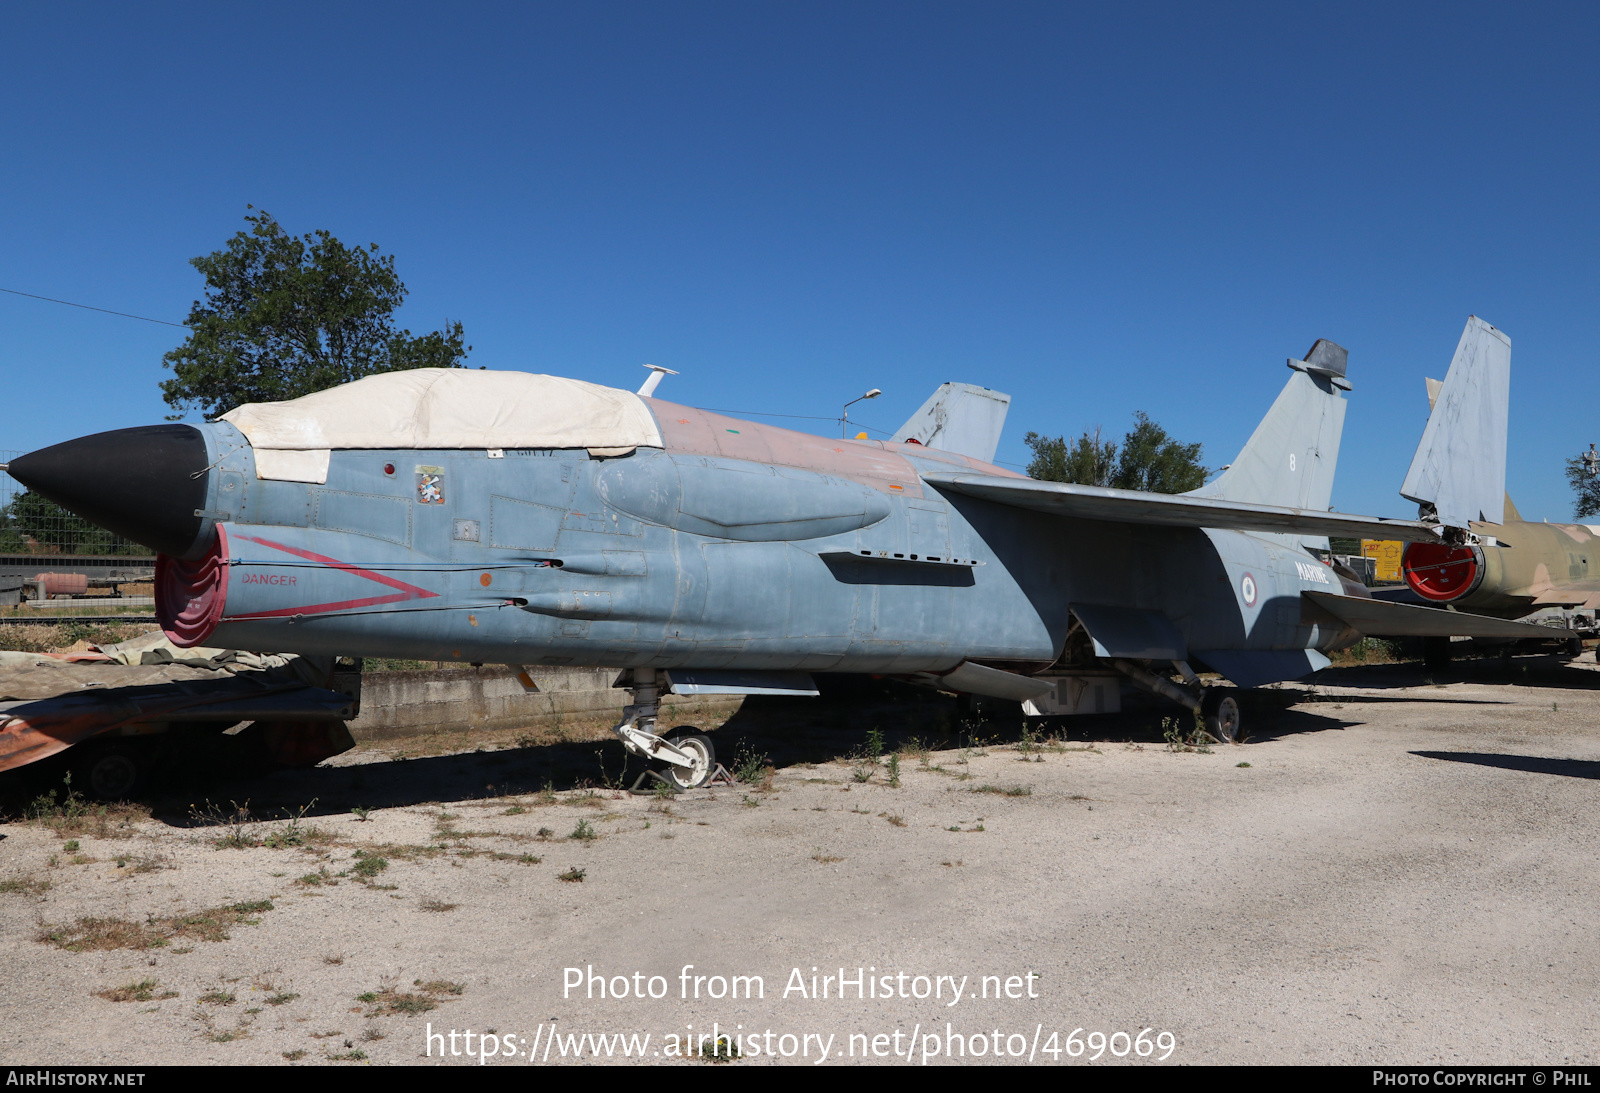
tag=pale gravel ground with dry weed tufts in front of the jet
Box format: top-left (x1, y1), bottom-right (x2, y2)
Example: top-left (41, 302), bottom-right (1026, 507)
top-left (0, 661), bottom-right (1600, 1066)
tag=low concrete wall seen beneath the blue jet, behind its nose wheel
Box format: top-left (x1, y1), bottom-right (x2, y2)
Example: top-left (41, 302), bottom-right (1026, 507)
top-left (350, 664), bottom-right (744, 739)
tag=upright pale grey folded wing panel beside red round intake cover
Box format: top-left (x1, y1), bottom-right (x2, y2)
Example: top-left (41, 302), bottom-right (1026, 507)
top-left (1400, 315), bottom-right (1510, 528)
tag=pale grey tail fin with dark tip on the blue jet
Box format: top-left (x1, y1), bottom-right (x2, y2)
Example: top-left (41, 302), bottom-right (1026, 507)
top-left (1192, 338), bottom-right (1350, 549)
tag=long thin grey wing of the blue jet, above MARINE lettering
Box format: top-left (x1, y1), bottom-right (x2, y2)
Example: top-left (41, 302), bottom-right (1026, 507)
top-left (923, 474), bottom-right (1438, 542)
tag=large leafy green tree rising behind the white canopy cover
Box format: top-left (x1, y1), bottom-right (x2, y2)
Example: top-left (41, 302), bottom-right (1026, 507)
top-left (162, 211), bottom-right (472, 418)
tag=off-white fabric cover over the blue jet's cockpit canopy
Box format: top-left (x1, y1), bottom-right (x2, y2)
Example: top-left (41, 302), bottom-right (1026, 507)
top-left (222, 368), bottom-right (661, 482)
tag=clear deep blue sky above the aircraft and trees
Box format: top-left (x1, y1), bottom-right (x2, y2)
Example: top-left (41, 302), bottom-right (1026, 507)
top-left (0, 2), bottom-right (1600, 518)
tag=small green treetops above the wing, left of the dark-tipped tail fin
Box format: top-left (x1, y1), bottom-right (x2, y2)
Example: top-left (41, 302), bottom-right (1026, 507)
top-left (1022, 410), bottom-right (1208, 493)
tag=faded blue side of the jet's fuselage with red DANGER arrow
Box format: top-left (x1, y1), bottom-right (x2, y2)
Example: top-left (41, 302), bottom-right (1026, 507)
top-left (202, 422), bottom-right (1346, 684)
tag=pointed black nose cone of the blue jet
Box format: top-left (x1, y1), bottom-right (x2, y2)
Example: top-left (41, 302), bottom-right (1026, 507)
top-left (10, 426), bottom-right (210, 557)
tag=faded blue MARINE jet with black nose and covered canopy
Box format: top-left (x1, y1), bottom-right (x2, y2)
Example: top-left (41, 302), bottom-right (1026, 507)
top-left (10, 341), bottom-right (1547, 786)
